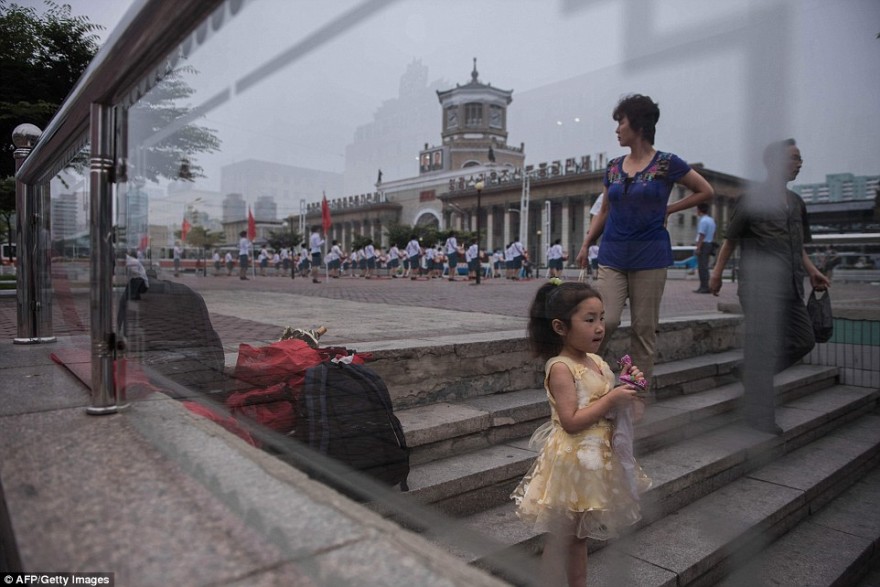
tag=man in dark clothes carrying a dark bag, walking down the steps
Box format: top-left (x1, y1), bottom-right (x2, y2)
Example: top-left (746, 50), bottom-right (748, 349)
top-left (709, 139), bottom-right (831, 434)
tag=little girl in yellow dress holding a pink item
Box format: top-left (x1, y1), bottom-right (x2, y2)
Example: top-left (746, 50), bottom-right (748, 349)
top-left (511, 279), bottom-right (651, 586)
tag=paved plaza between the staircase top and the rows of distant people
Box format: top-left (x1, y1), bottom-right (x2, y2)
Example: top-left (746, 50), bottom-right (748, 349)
top-left (0, 271), bottom-right (880, 352)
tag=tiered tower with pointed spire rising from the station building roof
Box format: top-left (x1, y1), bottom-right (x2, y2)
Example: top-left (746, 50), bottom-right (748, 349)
top-left (419, 58), bottom-right (525, 173)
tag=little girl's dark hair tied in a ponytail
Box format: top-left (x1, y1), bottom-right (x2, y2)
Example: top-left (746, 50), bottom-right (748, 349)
top-left (528, 282), bottom-right (602, 360)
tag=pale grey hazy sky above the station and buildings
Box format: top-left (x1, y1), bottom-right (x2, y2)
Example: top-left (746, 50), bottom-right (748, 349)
top-left (13, 0), bottom-right (880, 218)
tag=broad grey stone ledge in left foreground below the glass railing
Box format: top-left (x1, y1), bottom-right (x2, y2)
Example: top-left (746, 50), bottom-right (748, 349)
top-left (0, 382), bottom-right (502, 586)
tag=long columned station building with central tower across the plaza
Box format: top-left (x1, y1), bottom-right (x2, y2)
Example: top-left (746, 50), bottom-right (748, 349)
top-left (289, 60), bottom-right (744, 263)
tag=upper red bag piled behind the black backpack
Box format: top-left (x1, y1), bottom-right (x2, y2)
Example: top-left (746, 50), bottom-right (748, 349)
top-left (234, 338), bottom-right (322, 387)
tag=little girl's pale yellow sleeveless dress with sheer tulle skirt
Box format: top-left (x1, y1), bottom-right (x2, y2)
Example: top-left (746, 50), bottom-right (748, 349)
top-left (510, 354), bottom-right (651, 540)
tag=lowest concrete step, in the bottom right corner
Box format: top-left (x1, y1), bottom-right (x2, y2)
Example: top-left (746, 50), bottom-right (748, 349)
top-left (718, 468), bottom-right (880, 587)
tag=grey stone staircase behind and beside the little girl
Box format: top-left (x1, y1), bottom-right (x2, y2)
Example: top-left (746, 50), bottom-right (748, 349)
top-left (396, 350), bottom-right (880, 586)
